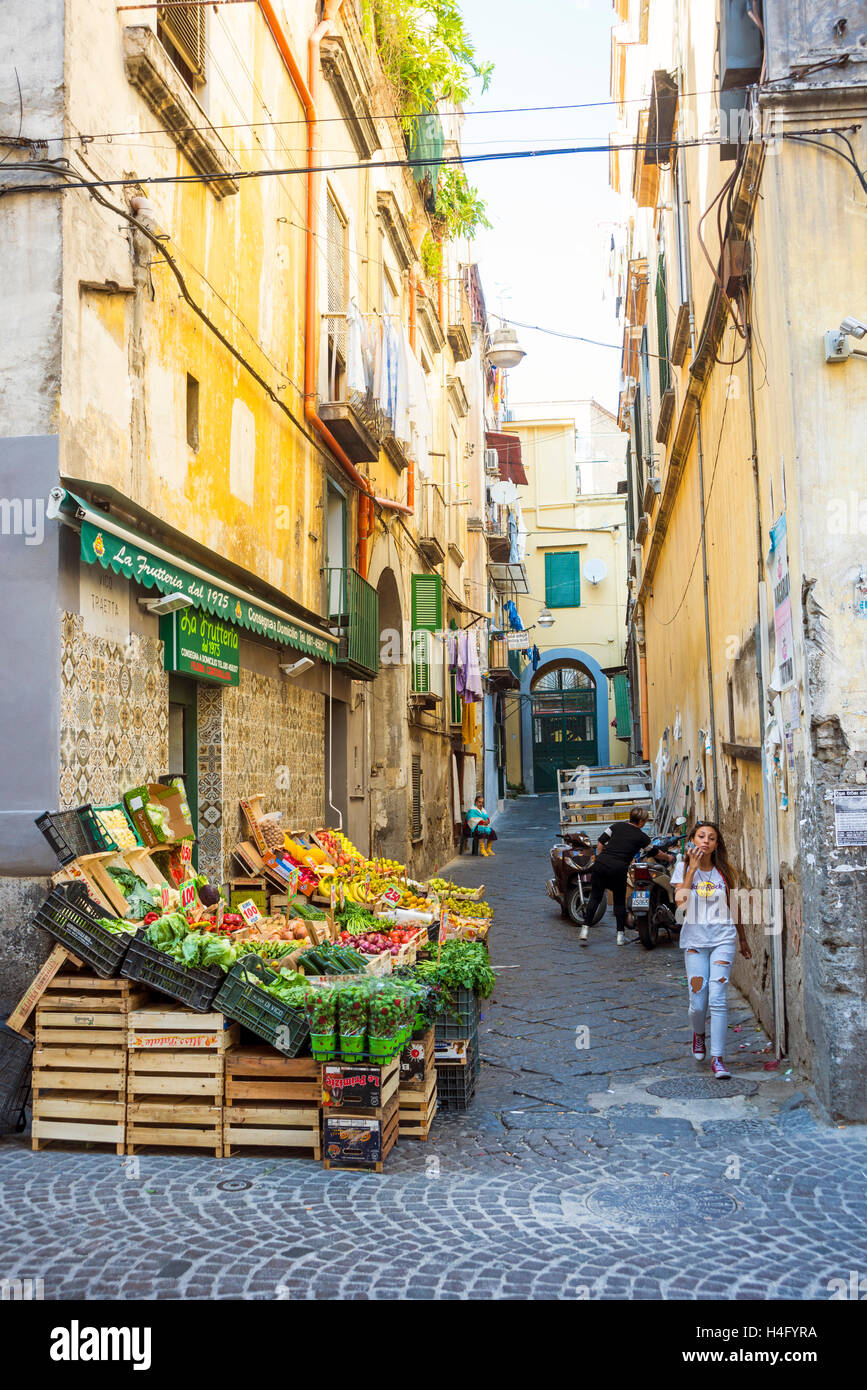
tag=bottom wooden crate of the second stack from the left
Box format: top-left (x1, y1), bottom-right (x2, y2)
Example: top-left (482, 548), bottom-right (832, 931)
top-left (126, 1047), bottom-right (225, 1158)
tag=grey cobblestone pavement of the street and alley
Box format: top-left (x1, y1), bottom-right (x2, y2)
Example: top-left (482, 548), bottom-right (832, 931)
top-left (0, 798), bottom-right (867, 1300)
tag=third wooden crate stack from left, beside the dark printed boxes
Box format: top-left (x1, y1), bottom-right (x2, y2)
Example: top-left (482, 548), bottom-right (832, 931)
top-left (222, 1047), bottom-right (322, 1159)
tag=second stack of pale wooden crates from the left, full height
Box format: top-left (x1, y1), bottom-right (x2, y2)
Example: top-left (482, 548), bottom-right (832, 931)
top-left (126, 1004), bottom-right (240, 1158)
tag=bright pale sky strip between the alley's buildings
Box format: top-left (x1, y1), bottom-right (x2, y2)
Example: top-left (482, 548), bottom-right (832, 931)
top-left (461, 0), bottom-right (622, 418)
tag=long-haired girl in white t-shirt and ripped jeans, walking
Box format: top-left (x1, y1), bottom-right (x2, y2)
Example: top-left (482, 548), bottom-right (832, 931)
top-left (671, 820), bottom-right (752, 1080)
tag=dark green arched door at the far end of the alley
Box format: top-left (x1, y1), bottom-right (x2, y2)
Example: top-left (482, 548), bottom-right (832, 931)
top-left (531, 660), bottom-right (599, 792)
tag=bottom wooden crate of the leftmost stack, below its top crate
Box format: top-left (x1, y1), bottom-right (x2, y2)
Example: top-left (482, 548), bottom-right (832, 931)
top-left (32, 1039), bottom-right (126, 1154)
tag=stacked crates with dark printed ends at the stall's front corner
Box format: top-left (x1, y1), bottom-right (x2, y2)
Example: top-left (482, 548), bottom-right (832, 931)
top-left (322, 1058), bottom-right (400, 1173)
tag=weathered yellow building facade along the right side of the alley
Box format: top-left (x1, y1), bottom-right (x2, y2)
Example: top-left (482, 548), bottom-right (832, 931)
top-left (611, 0), bottom-right (867, 1119)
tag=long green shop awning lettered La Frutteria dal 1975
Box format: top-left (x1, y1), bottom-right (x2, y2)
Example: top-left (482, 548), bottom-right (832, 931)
top-left (53, 488), bottom-right (338, 662)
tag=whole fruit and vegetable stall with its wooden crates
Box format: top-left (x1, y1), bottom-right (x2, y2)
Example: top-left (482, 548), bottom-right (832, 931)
top-left (0, 778), bottom-right (495, 1172)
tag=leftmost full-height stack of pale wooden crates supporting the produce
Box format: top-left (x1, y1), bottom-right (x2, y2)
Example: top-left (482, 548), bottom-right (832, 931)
top-left (32, 973), bottom-right (146, 1154)
